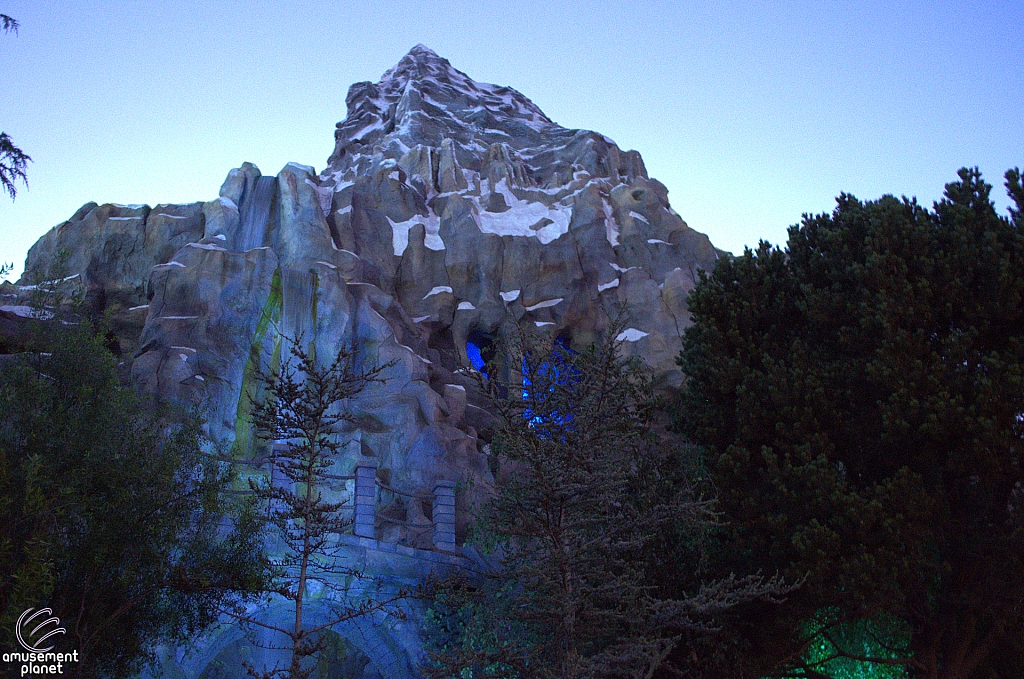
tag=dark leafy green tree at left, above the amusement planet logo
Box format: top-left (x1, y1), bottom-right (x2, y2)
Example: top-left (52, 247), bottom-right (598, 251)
top-left (0, 321), bottom-right (259, 677)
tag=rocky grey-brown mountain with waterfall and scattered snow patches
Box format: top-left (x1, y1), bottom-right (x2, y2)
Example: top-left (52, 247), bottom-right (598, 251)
top-left (6, 45), bottom-right (717, 546)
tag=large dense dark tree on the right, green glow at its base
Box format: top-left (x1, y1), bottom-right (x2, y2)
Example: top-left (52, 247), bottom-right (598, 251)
top-left (681, 170), bottom-right (1024, 678)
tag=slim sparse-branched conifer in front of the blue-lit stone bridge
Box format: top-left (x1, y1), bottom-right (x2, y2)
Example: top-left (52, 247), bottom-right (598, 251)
top-left (230, 340), bottom-right (409, 679)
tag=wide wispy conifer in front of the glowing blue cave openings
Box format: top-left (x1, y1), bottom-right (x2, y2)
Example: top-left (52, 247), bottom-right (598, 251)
top-left (428, 328), bottom-right (778, 679)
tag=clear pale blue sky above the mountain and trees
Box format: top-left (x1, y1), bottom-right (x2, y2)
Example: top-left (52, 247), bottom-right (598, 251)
top-left (0, 0), bottom-right (1024, 274)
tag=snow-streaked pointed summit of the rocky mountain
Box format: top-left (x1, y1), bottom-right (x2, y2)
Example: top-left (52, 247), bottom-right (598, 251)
top-left (325, 45), bottom-right (647, 196)
